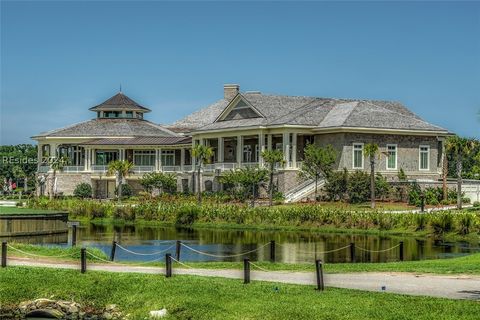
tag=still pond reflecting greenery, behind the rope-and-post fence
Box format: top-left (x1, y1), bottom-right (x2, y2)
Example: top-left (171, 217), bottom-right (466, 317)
top-left (7, 223), bottom-right (480, 263)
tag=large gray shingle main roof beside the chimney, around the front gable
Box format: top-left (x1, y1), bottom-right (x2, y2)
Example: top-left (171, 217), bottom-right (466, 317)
top-left (171, 93), bottom-right (447, 132)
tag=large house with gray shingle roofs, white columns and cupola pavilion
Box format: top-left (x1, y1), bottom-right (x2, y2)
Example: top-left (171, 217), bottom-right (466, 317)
top-left (33, 85), bottom-right (448, 199)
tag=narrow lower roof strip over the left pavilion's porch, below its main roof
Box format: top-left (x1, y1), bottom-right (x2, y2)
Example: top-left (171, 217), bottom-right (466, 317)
top-left (82, 137), bottom-right (188, 146)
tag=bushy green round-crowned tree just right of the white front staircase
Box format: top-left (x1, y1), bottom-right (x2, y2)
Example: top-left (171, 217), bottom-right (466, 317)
top-left (300, 144), bottom-right (337, 200)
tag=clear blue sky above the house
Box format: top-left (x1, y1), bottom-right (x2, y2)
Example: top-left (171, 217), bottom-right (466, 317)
top-left (0, 1), bottom-right (480, 144)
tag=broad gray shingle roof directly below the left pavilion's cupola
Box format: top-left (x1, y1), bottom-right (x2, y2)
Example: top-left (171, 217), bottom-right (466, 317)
top-left (34, 118), bottom-right (180, 138)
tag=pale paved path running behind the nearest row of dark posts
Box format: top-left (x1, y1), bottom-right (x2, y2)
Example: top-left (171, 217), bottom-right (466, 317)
top-left (8, 258), bottom-right (480, 301)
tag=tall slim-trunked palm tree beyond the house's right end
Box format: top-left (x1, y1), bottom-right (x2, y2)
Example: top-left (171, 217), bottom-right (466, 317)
top-left (445, 136), bottom-right (478, 209)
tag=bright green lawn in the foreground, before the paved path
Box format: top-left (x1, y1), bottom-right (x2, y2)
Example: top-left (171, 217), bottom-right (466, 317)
top-left (0, 267), bottom-right (480, 320)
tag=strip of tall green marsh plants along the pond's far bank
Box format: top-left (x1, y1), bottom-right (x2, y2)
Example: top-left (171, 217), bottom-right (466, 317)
top-left (25, 197), bottom-right (480, 236)
